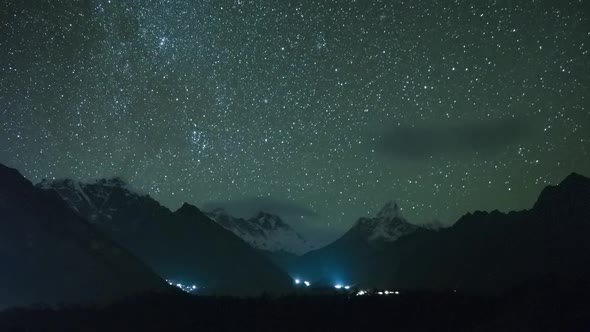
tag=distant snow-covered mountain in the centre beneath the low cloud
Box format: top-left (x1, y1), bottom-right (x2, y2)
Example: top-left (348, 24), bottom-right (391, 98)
top-left (207, 209), bottom-right (313, 255)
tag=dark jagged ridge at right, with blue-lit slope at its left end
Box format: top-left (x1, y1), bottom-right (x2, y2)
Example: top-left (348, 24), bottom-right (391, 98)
top-left (294, 174), bottom-right (590, 294)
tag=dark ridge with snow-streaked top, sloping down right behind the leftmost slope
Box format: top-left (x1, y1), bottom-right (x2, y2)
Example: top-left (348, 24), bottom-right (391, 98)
top-left (38, 178), bottom-right (292, 295)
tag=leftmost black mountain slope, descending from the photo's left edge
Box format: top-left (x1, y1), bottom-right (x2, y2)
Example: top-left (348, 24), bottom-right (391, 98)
top-left (0, 164), bottom-right (172, 308)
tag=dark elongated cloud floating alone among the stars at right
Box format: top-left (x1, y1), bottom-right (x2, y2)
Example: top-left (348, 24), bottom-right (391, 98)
top-left (377, 118), bottom-right (531, 160)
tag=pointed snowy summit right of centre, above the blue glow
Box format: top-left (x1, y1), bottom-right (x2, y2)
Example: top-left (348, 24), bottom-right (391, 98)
top-left (350, 201), bottom-right (418, 242)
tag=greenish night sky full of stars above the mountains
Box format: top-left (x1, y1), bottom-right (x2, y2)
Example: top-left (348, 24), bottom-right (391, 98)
top-left (0, 0), bottom-right (590, 241)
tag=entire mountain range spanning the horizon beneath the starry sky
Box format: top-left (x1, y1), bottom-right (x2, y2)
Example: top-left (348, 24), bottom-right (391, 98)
top-left (0, 158), bottom-right (590, 308)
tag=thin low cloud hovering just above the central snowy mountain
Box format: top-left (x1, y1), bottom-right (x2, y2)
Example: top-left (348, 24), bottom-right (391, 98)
top-left (203, 197), bottom-right (318, 218)
